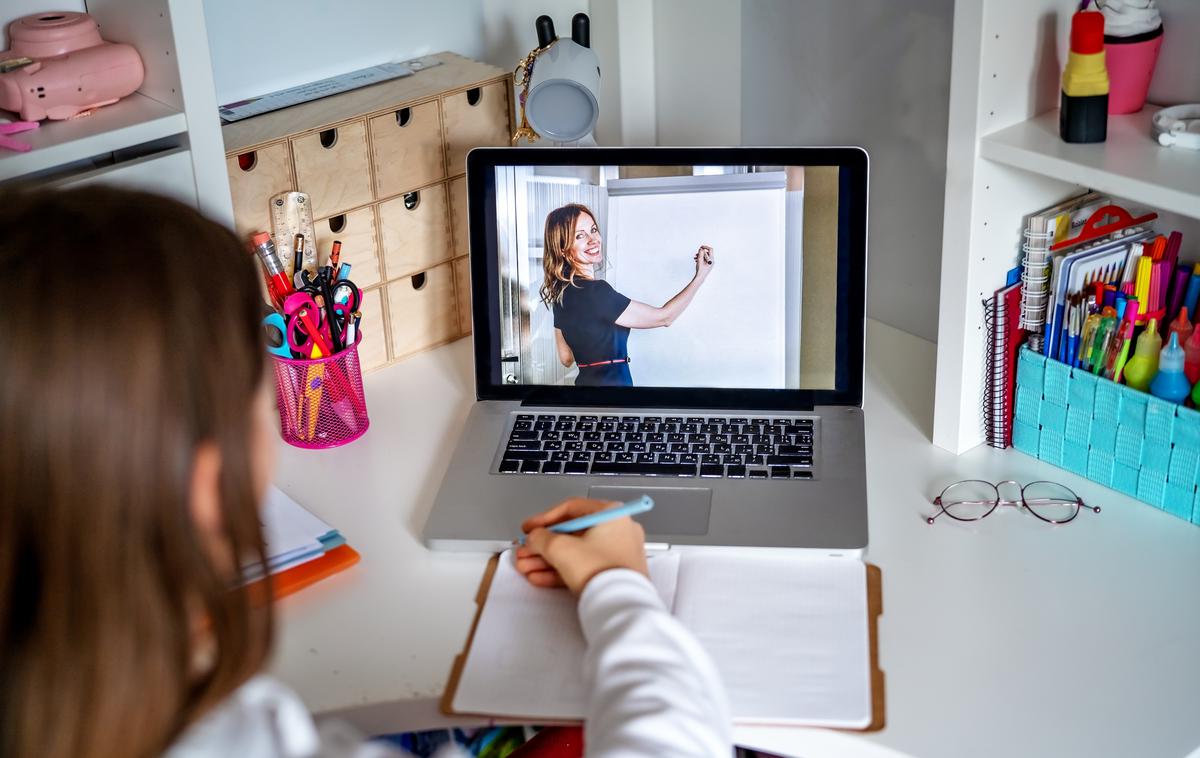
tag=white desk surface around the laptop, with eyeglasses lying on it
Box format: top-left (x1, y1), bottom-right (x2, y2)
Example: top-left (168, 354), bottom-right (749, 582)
top-left (267, 321), bottom-right (1200, 758)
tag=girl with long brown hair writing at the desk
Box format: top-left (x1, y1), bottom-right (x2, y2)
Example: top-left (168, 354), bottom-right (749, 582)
top-left (0, 188), bottom-right (731, 758)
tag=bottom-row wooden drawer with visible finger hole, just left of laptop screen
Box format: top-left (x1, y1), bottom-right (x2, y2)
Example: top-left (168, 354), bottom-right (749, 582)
top-left (388, 264), bottom-right (462, 357)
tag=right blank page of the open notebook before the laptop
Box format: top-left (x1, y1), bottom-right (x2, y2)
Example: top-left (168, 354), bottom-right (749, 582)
top-left (674, 552), bottom-right (871, 728)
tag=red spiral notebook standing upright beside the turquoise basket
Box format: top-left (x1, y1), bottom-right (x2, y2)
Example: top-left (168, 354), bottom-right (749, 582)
top-left (983, 284), bottom-right (1026, 449)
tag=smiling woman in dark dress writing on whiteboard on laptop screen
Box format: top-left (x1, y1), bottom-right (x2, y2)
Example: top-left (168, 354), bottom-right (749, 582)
top-left (539, 203), bottom-right (713, 386)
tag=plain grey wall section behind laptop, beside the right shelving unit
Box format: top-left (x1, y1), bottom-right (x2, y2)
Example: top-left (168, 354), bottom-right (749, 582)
top-left (742, 0), bottom-right (954, 339)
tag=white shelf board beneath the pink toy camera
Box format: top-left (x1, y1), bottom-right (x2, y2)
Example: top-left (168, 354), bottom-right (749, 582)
top-left (0, 92), bottom-right (187, 181)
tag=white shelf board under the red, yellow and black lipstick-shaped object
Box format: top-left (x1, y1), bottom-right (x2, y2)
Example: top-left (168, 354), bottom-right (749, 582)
top-left (979, 106), bottom-right (1200, 218)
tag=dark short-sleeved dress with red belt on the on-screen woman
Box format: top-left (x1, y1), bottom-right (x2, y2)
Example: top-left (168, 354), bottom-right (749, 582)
top-left (554, 279), bottom-right (634, 387)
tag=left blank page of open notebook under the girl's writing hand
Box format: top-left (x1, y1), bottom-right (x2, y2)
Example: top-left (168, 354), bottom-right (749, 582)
top-left (452, 551), bottom-right (679, 720)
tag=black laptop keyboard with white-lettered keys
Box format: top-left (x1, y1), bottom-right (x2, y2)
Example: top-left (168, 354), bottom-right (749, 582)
top-left (497, 414), bottom-right (816, 480)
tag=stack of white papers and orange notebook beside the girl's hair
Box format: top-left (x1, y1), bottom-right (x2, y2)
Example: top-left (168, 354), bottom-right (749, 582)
top-left (245, 487), bottom-right (359, 600)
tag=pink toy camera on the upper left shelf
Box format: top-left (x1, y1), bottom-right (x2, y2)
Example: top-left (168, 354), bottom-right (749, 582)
top-left (0, 11), bottom-right (145, 121)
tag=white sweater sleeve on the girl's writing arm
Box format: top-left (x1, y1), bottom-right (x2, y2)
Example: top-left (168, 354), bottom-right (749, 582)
top-left (580, 569), bottom-right (733, 758)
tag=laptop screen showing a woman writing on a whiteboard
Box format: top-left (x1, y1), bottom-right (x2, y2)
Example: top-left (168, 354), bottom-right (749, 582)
top-left (470, 149), bottom-right (865, 407)
